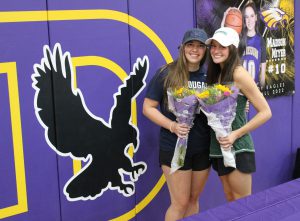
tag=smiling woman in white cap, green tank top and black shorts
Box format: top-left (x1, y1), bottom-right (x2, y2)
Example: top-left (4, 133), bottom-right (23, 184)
top-left (206, 27), bottom-right (272, 201)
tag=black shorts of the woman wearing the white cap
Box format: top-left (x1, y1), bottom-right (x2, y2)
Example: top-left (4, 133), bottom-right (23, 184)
top-left (211, 152), bottom-right (256, 176)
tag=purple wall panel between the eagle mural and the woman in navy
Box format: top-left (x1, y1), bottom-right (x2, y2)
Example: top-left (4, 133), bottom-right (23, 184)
top-left (129, 0), bottom-right (193, 221)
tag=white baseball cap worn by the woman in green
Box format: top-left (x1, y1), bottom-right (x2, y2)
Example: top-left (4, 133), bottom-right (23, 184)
top-left (205, 27), bottom-right (240, 48)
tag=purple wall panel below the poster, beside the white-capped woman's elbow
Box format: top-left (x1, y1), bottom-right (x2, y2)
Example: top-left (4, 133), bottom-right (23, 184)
top-left (252, 96), bottom-right (292, 189)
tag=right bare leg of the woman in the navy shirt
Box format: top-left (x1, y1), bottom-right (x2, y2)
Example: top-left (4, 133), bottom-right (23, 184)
top-left (184, 169), bottom-right (209, 217)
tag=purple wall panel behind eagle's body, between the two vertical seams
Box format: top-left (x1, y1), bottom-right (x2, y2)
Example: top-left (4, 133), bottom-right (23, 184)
top-left (48, 1), bottom-right (135, 221)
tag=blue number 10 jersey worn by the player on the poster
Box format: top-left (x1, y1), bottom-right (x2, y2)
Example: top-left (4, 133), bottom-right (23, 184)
top-left (242, 34), bottom-right (266, 83)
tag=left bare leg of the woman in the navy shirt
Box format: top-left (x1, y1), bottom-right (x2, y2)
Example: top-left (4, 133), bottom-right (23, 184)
top-left (162, 165), bottom-right (192, 221)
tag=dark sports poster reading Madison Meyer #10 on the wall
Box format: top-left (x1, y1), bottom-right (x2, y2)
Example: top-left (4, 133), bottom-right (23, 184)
top-left (196, 0), bottom-right (295, 98)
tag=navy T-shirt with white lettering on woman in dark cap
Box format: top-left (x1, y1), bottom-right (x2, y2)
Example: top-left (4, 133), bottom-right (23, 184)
top-left (146, 64), bottom-right (210, 154)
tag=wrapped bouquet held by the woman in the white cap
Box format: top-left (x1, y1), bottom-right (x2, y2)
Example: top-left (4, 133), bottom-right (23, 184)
top-left (196, 84), bottom-right (239, 168)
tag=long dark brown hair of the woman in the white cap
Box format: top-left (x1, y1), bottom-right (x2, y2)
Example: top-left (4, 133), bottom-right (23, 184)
top-left (207, 45), bottom-right (241, 85)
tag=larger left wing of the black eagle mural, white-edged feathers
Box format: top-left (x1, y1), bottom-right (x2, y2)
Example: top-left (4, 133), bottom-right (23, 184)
top-left (32, 44), bottom-right (109, 158)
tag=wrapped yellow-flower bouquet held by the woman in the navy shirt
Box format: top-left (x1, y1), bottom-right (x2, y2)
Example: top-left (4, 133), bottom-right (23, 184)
top-left (167, 87), bottom-right (198, 173)
